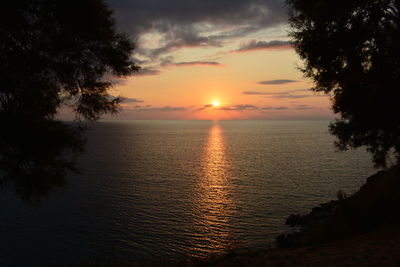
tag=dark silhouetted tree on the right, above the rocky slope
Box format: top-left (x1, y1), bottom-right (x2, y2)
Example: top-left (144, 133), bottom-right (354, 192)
top-left (287, 0), bottom-right (400, 167)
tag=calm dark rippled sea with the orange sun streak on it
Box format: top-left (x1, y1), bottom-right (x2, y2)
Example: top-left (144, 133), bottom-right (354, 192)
top-left (0, 121), bottom-right (374, 266)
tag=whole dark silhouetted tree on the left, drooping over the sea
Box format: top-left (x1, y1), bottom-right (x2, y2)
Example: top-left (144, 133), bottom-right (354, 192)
top-left (0, 0), bottom-right (138, 202)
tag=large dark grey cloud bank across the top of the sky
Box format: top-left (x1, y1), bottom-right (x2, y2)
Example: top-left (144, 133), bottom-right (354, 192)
top-left (109, 0), bottom-right (287, 58)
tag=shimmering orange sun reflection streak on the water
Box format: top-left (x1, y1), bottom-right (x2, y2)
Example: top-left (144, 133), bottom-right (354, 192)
top-left (193, 122), bottom-right (235, 254)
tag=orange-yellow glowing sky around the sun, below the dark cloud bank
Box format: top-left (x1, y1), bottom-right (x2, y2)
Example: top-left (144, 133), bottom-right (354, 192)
top-left (88, 48), bottom-right (332, 120)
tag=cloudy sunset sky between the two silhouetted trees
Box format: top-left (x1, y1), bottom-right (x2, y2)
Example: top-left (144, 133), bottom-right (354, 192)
top-left (88, 0), bottom-right (333, 120)
